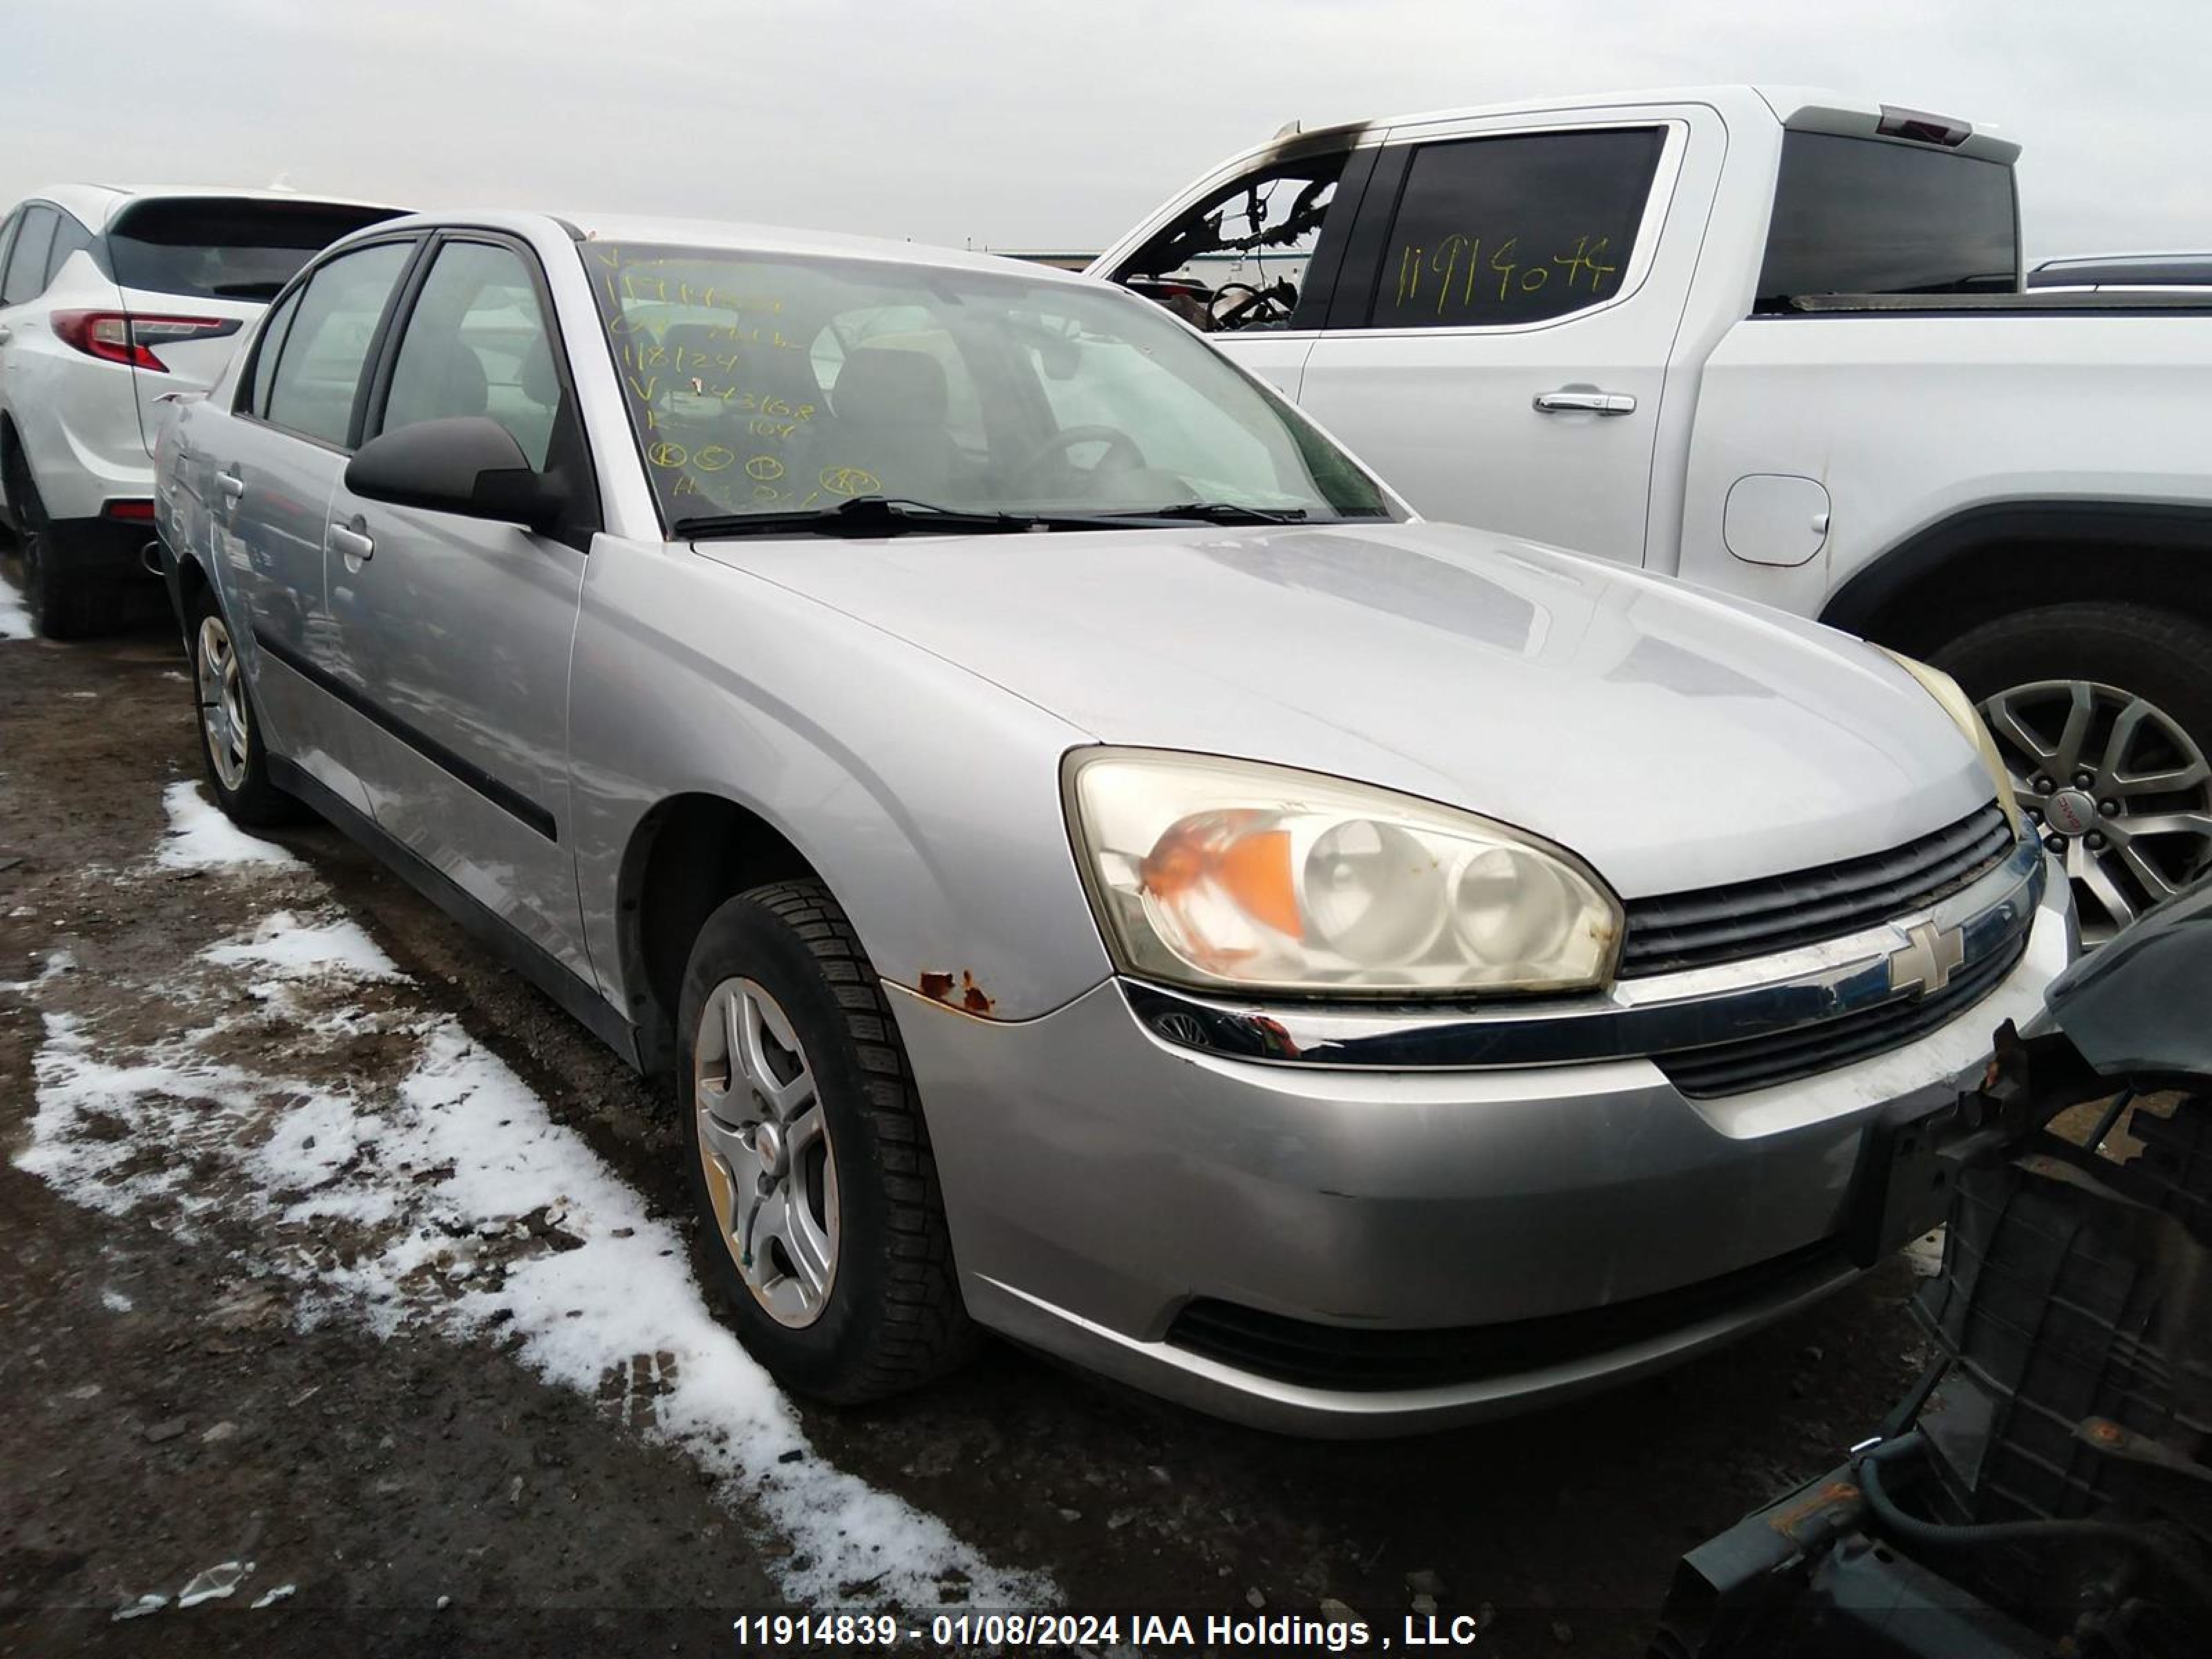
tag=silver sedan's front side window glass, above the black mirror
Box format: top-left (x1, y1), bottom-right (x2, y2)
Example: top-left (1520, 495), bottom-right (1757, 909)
top-left (383, 241), bottom-right (560, 471)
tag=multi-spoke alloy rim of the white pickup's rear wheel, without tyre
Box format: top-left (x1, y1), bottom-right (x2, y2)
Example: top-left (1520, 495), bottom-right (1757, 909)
top-left (1982, 679), bottom-right (2212, 944)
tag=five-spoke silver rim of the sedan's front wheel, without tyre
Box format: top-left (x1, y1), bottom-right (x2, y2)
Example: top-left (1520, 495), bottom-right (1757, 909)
top-left (693, 977), bottom-right (838, 1329)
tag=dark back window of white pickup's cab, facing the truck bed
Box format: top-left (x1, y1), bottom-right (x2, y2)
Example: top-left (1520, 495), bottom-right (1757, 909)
top-left (1756, 133), bottom-right (2020, 314)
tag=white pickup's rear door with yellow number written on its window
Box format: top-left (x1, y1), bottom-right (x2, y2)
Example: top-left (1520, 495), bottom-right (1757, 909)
top-left (1298, 106), bottom-right (1723, 564)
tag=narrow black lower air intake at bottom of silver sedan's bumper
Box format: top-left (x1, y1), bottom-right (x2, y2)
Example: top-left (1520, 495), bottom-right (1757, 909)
top-left (1168, 1243), bottom-right (1849, 1394)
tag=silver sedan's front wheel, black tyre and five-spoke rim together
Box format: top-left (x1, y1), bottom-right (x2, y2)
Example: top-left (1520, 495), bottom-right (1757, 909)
top-left (677, 881), bottom-right (971, 1405)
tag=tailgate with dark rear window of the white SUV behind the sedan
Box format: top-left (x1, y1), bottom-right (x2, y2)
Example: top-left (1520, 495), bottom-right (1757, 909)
top-left (104, 197), bottom-right (406, 449)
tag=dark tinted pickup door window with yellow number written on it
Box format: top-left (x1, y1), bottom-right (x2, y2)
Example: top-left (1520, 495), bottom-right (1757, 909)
top-left (1367, 126), bottom-right (1666, 328)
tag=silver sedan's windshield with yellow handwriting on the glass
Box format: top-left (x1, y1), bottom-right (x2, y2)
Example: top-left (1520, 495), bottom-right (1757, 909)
top-left (579, 241), bottom-right (1389, 527)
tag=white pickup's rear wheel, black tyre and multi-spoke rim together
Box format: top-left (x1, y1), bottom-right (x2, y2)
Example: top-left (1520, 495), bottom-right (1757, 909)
top-left (1933, 601), bottom-right (2212, 944)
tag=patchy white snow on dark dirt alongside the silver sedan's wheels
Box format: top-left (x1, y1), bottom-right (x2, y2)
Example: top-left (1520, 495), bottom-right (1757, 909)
top-left (15, 827), bottom-right (1055, 1608)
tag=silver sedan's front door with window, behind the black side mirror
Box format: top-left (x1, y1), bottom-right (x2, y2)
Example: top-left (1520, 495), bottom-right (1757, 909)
top-left (328, 232), bottom-right (604, 980)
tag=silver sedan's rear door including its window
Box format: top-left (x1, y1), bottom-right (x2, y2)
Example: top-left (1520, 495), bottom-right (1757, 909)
top-left (227, 236), bottom-right (420, 812)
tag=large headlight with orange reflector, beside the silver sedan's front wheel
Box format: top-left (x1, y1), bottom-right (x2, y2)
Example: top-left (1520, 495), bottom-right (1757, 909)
top-left (1066, 750), bottom-right (1622, 995)
